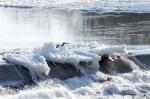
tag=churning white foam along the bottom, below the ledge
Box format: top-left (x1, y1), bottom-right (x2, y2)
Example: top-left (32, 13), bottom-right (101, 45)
top-left (0, 71), bottom-right (150, 99)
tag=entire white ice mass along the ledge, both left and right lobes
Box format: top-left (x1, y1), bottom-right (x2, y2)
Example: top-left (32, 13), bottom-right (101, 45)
top-left (4, 42), bottom-right (127, 79)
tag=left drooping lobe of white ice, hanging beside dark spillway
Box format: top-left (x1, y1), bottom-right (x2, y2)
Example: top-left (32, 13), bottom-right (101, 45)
top-left (4, 53), bottom-right (50, 80)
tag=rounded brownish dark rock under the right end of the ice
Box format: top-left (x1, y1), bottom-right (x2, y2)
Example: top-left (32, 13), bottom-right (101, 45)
top-left (99, 55), bottom-right (133, 74)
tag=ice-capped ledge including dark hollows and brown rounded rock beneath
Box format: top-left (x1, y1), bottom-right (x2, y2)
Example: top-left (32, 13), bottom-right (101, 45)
top-left (0, 42), bottom-right (137, 84)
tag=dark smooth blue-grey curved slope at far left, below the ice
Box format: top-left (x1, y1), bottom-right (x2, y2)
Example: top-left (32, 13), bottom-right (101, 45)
top-left (0, 61), bottom-right (33, 87)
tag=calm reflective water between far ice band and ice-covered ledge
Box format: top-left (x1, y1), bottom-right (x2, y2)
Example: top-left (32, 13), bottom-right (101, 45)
top-left (0, 8), bottom-right (150, 48)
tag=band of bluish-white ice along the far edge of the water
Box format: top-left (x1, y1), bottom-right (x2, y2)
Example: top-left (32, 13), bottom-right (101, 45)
top-left (0, 0), bottom-right (150, 13)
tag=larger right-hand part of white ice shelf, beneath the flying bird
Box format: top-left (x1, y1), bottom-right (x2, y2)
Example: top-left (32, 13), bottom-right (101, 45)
top-left (35, 42), bottom-right (127, 71)
